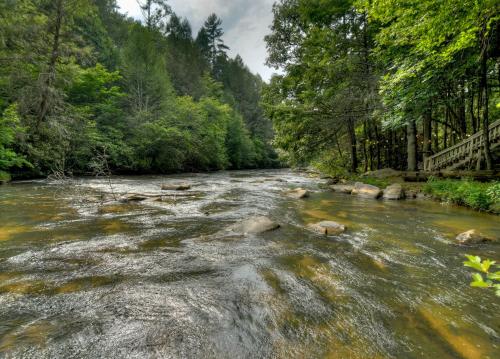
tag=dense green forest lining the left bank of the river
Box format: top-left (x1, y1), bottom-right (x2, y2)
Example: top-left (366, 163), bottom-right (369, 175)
top-left (0, 0), bottom-right (278, 178)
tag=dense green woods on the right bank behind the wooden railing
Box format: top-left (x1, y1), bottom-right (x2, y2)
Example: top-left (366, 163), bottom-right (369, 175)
top-left (264, 0), bottom-right (500, 174)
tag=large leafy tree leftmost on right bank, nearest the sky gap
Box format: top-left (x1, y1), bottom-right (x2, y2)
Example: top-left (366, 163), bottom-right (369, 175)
top-left (266, 0), bottom-right (377, 172)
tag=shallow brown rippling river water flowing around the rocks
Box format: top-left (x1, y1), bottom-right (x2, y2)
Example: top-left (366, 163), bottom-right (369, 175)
top-left (0, 171), bottom-right (500, 358)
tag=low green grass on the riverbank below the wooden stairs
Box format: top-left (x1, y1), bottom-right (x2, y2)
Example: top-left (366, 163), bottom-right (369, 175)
top-left (423, 178), bottom-right (500, 213)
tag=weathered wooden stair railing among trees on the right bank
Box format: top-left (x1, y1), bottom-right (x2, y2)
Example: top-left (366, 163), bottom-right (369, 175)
top-left (424, 120), bottom-right (500, 171)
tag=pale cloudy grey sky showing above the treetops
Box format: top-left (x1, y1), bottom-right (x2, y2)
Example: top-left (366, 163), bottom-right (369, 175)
top-left (117, 0), bottom-right (275, 81)
